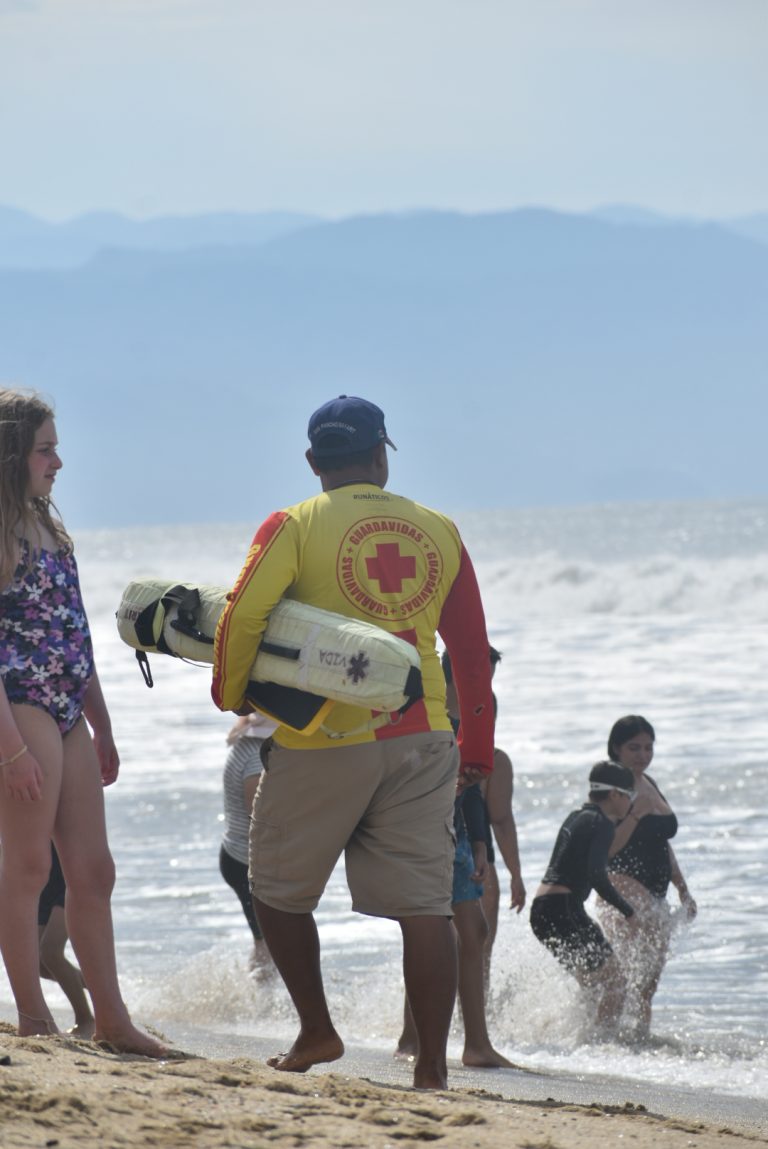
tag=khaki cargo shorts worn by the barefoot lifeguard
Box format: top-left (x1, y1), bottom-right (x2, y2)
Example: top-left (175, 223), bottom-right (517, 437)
top-left (249, 731), bottom-right (459, 918)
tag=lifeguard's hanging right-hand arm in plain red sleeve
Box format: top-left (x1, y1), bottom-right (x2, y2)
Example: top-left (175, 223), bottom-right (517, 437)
top-left (437, 545), bottom-right (493, 780)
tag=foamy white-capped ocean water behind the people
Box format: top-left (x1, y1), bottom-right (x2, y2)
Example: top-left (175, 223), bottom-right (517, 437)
top-left (0, 502), bottom-right (768, 1100)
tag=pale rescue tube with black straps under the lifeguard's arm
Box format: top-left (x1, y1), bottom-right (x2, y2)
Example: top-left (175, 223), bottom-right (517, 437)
top-left (117, 579), bottom-right (423, 733)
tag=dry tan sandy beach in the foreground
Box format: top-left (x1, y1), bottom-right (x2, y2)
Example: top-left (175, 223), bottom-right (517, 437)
top-left (0, 1025), bottom-right (768, 1149)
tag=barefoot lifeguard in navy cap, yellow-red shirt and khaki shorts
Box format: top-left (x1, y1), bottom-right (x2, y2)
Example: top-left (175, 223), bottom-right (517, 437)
top-left (213, 395), bottom-right (493, 1089)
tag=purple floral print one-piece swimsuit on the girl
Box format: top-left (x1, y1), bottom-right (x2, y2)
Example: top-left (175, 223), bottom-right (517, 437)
top-left (0, 539), bottom-right (93, 734)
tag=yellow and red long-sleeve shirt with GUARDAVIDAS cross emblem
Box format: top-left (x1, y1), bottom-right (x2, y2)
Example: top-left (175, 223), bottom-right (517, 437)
top-left (212, 483), bottom-right (493, 770)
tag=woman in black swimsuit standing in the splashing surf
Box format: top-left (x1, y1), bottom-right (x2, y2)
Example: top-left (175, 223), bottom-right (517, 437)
top-left (600, 715), bottom-right (696, 1039)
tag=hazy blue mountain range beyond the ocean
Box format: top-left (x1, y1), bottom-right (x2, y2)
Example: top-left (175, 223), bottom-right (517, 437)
top-left (0, 208), bottom-right (768, 525)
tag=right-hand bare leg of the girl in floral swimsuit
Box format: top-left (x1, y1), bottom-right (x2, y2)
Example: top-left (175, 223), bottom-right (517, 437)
top-left (53, 719), bottom-right (168, 1057)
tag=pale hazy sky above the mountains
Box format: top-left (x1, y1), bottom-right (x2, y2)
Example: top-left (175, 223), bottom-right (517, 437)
top-left (0, 0), bottom-right (768, 218)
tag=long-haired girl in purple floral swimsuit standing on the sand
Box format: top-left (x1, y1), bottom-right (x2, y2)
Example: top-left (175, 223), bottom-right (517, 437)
top-left (0, 390), bottom-right (167, 1057)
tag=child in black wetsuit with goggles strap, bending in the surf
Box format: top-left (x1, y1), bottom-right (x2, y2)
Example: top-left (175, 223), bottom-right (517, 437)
top-left (530, 762), bottom-right (635, 1028)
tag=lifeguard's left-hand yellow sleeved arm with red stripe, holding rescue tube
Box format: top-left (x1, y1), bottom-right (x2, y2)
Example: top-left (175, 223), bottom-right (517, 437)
top-left (210, 511), bottom-right (297, 710)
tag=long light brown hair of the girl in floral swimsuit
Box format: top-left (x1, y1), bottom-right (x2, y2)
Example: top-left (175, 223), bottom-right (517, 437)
top-left (0, 387), bottom-right (72, 587)
